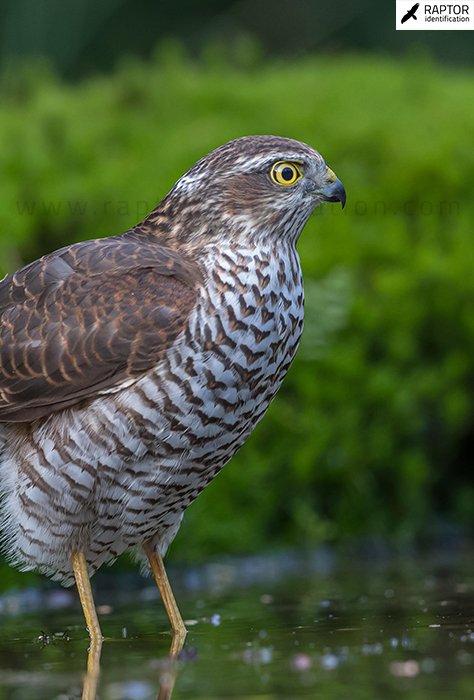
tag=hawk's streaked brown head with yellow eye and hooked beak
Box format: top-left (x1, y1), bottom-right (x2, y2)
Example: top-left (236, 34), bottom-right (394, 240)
top-left (152, 136), bottom-right (346, 244)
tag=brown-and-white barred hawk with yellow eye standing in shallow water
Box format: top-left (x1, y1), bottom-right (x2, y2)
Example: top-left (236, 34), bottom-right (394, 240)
top-left (0, 136), bottom-right (346, 640)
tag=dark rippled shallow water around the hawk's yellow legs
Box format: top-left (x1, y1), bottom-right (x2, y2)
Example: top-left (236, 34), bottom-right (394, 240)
top-left (0, 548), bottom-right (474, 700)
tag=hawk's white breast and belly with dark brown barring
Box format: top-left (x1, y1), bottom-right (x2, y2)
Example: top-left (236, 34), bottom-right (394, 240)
top-left (1, 244), bottom-right (303, 585)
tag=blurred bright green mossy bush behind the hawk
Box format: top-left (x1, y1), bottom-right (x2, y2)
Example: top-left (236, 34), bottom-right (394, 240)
top-left (0, 42), bottom-right (474, 558)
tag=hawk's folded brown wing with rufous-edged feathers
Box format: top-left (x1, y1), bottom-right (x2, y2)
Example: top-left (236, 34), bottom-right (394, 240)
top-left (0, 234), bottom-right (200, 422)
